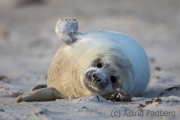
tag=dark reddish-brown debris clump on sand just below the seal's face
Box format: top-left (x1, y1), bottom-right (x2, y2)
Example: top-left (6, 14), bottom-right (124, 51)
top-left (109, 88), bottom-right (132, 102)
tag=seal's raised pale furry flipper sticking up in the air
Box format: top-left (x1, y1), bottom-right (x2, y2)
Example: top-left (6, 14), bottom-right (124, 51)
top-left (55, 19), bottom-right (78, 45)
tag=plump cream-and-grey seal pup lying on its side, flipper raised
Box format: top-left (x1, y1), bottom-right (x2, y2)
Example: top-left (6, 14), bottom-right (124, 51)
top-left (17, 19), bottom-right (150, 102)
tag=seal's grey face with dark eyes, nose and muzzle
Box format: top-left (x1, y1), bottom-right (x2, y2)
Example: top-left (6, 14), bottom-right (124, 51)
top-left (84, 58), bottom-right (115, 95)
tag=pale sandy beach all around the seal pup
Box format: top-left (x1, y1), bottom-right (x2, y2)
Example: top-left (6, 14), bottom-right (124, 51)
top-left (0, 0), bottom-right (180, 120)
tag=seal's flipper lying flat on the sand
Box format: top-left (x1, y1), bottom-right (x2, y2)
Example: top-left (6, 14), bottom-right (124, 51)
top-left (16, 88), bottom-right (62, 102)
